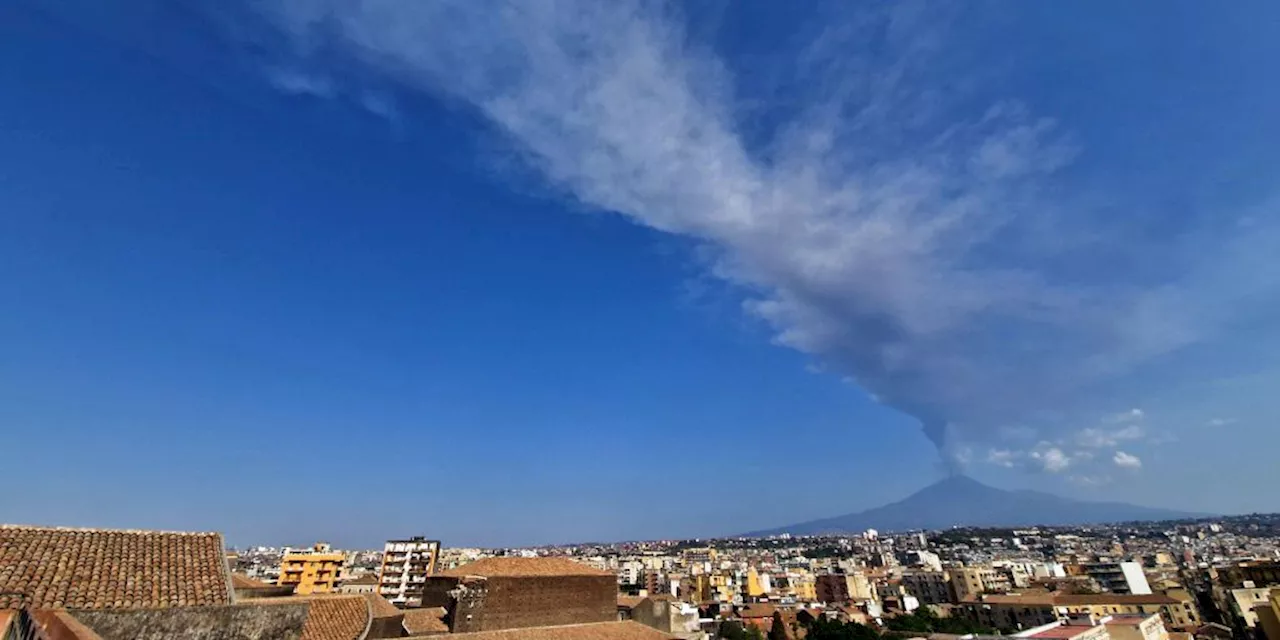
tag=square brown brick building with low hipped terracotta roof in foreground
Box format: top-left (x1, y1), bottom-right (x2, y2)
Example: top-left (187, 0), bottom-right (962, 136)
top-left (422, 557), bottom-right (618, 634)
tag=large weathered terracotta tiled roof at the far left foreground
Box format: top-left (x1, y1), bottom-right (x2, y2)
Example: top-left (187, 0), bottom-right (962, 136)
top-left (0, 525), bottom-right (230, 609)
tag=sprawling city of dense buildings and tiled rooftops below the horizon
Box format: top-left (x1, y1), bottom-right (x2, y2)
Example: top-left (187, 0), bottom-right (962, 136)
top-left (0, 515), bottom-right (1280, 640)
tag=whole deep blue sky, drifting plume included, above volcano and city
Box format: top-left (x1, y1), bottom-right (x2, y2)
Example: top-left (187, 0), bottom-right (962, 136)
top-left (0, 0), bottom-right (1280, 545)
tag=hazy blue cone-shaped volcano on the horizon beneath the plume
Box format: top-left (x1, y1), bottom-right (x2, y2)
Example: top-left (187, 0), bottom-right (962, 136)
top-left (746, 476), bottom-right (1206, 536)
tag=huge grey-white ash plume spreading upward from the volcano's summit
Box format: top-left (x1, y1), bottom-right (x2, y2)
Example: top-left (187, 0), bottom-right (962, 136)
top-left (238, 0), bottom-right (1275, 471)
